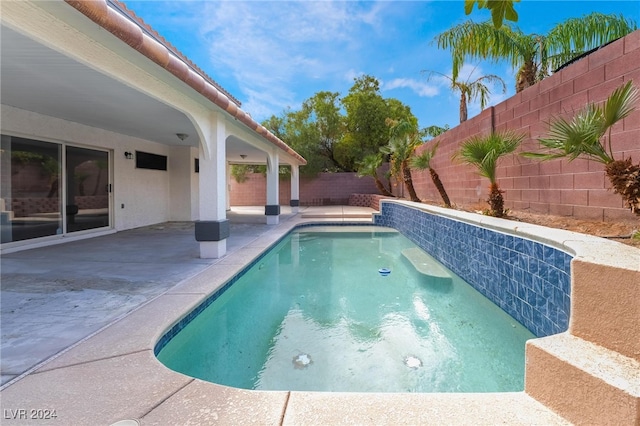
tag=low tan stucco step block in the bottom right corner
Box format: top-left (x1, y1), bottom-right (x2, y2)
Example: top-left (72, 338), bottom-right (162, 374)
top-left (525, 333), bottom-right (640, 425)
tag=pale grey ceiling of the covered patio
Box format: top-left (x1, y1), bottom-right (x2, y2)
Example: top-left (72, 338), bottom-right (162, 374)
top-left (0, 25), bottom-right (280, 164)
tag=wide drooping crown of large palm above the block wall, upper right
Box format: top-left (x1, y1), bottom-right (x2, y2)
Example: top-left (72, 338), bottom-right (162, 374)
top-left (435, 13), bottom-right (636, 92)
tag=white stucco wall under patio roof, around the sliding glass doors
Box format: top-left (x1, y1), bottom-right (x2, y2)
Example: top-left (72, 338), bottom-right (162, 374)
top-left (1, 105), bottom-right (191, 231)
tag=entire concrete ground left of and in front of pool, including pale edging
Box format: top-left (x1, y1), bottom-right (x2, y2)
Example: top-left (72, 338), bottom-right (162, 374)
top-left (0, 206), bottom-right (584, 425)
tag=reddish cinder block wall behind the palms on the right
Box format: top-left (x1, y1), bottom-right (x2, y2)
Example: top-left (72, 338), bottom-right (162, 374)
top-left (413, 31), bottom-right (640, 220)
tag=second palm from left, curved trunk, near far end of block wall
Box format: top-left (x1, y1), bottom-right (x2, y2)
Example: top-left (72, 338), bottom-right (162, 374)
top-left (380, 119), bottom-right (422, 203)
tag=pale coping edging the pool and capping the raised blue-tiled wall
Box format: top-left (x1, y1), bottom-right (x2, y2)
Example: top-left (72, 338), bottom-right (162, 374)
top-left (1, 201), bottom-right (640, 424)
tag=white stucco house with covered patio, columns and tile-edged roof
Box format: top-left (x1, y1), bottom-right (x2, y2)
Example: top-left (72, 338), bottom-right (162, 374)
top-left (0, 0), bottom-right (306, 253)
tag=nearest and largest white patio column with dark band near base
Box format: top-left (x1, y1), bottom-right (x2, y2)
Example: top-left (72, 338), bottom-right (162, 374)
top-left (196, 113), bottom-right (229, 259)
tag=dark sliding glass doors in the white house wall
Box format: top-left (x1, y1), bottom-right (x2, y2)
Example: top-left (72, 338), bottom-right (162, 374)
top-left (0, 135), bottom-right (110, 243)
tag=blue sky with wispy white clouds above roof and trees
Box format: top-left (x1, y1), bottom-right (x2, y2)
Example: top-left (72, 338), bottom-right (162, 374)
top-left (125, 0), bottom-right (640, 127)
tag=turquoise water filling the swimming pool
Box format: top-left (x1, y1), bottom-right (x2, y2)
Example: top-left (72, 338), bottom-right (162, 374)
top-left (157, 226), bottom-right (534, 392)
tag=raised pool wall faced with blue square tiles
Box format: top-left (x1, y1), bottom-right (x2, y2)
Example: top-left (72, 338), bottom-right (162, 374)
top-left (374, 202), bottom-right (572, 337)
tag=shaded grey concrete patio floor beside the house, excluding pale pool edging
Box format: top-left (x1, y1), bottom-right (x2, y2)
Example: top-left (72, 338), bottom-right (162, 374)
top-left (0, 206), bottom-right (373, 385)
